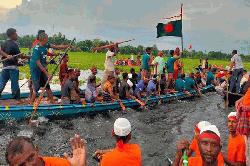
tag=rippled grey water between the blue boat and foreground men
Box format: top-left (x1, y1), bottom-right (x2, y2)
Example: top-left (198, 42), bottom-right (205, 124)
top-left (0, 93), bottom-right (234, 166)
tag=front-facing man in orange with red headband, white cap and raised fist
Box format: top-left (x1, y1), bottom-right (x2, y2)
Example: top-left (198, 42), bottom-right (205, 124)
top-left (173, 125), bottom-right (224, 166)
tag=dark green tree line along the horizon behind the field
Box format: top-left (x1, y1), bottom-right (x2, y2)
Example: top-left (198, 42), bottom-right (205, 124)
top-left (0, 32), bottom-right (250, 61)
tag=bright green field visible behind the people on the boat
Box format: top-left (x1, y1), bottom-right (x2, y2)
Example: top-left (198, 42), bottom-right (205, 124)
top-left (20, 49), bottom-right (250, 78)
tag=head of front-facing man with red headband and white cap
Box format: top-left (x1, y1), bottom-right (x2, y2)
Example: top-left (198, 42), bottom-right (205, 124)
top-left (198, 125), bottom-right (221, 166)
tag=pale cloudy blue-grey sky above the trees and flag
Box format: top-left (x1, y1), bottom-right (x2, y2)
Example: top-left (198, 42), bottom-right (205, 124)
top-left (0, 0), bottom-right (250, 53)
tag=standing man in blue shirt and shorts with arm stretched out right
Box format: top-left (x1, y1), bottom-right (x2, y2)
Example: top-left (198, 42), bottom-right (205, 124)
top-left (30, 33), bottom-right (70, 103)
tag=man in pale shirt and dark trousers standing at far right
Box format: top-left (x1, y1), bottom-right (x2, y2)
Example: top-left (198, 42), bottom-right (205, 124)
top-left (229, 50), bottom-right (243, 93)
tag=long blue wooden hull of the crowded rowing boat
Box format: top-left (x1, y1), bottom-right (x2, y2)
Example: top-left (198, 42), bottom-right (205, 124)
top-left (0, 86), bottom-right (214, 121)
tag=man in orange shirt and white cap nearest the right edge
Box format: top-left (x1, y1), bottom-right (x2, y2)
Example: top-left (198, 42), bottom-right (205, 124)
top-left (224, 112), bottom-right (246, 166)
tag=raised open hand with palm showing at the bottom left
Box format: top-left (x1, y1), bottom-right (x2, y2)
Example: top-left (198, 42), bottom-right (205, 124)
top-left (64, 134), bottom-right (87, 166)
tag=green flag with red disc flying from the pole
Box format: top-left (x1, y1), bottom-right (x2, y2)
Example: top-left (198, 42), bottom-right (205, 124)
top-left (157, 20), bottom-right (182, 38)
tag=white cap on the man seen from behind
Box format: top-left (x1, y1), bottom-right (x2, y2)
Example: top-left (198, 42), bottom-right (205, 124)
top-left (114, 118), bottom-right (131, 137)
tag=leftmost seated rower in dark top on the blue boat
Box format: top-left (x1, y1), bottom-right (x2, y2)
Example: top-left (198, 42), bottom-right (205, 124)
top-left (62, 69), bottom-right (81, 104)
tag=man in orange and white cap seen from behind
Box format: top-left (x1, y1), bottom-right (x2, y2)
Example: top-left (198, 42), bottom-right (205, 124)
top-left (95, 118), bottom-right (142, 166)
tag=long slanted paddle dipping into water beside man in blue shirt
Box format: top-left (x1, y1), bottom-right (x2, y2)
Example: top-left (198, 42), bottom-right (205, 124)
top-left (29, 38), bottom-right (76, 122)
